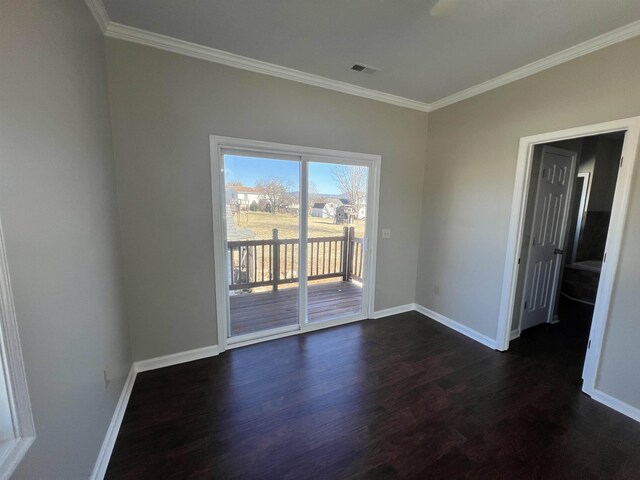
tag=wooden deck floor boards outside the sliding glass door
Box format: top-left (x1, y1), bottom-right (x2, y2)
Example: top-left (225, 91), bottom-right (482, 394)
top-left (231, 281), bottom-right (362, 336)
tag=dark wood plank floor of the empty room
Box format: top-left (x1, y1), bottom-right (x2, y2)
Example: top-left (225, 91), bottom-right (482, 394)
top-left (107, 312), bottom-right (640, 479)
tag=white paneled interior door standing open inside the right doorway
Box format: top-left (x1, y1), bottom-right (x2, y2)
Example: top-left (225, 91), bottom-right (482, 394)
top-left (521, 146), bottom-right (577, 330)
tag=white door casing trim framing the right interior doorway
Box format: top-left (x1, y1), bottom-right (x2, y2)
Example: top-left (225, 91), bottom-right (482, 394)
top-left (496, 117), bottom-right (640, 402)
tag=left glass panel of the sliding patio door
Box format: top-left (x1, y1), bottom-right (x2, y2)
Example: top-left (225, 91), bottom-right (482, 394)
top-left (223, 152), bottom-right (301, 340)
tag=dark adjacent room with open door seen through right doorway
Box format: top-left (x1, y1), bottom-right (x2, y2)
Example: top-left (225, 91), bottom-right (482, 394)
top-left (512, 131), bottom-right (625, 374)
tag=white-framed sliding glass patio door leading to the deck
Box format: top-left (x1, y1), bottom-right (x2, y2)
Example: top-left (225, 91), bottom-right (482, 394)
top-left (211, 137), bottom-right (380, 349)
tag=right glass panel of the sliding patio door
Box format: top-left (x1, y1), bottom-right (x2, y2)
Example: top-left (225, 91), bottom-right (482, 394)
top-left (306, 162), bottom-right (369, 323)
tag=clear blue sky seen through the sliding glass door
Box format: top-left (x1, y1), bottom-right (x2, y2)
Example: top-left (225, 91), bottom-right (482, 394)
top-left (224, 155), bottom-right (341, 194)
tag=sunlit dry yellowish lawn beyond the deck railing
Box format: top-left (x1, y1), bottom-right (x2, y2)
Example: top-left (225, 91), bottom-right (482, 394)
top-left (234, 212), bottom-right (365, 240)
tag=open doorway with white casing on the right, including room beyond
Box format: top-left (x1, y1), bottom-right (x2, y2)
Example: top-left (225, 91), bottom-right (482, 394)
top-left (497, 117), bottom-right (640, 396)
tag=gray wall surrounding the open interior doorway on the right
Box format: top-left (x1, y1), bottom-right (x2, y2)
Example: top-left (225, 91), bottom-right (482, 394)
top-left (416, 34), bottom-right (640, 407)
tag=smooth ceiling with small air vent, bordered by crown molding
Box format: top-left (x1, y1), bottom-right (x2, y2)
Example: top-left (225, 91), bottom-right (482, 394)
top-left (104, 0), bottom-right (640, 103)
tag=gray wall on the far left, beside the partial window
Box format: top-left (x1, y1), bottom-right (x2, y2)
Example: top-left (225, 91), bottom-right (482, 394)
top-left (0, 0), bottom-right (130, 479)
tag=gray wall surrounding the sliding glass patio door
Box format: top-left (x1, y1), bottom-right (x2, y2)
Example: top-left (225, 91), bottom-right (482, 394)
top-left (107, 39), bottom-right (427, 359)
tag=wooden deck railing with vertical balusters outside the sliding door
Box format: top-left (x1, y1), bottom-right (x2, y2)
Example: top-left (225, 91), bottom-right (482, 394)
top-left (227, 227), bottom-right (364, 290)
